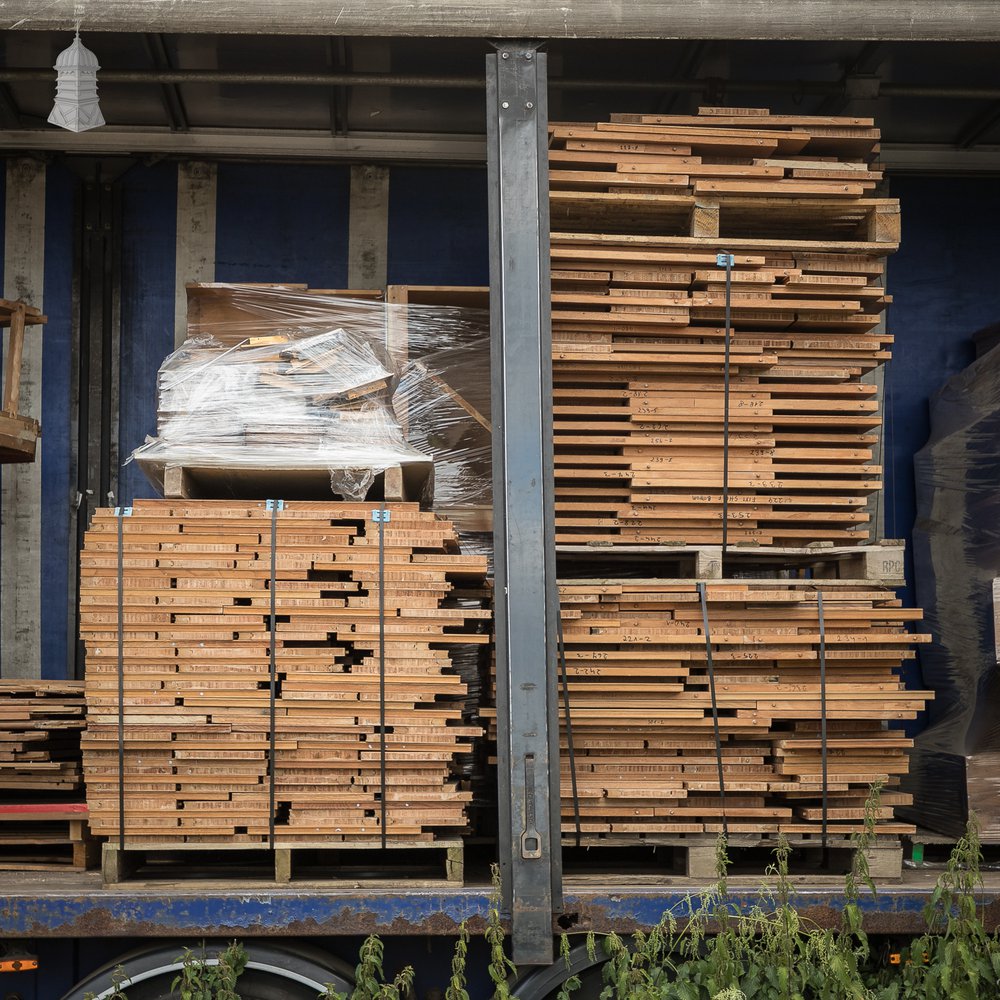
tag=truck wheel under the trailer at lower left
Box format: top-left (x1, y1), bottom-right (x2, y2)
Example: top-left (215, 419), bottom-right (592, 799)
top-left (63, 940), bottom-right (354, 1000)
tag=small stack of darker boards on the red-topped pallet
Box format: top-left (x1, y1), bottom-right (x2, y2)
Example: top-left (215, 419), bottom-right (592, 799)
top-left (0, 681), bottom-right (86, 802)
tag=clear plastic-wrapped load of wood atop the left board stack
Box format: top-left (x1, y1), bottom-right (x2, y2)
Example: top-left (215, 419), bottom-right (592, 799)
top-left (132, 285), bottom-right (491, 511)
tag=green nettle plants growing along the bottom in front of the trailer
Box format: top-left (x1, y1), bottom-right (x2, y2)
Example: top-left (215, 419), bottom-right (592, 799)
top-left (82, 786), bottom-right (1000, 1000)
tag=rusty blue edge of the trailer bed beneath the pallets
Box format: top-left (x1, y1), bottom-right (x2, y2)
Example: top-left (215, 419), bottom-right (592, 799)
top-left (0, 869), bottom-right (1000, 939)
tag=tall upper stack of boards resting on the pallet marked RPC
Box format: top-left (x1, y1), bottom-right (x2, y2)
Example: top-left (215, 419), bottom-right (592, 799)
top-left (549, 109), bottom-right (898, 546)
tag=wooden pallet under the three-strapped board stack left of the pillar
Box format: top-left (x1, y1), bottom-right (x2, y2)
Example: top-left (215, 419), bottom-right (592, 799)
top-left (101, 839), bottom-right (465, 888)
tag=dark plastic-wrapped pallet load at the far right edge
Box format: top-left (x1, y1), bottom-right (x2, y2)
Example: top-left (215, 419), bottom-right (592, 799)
top-left (911, 340), bottom-right (1000, 841)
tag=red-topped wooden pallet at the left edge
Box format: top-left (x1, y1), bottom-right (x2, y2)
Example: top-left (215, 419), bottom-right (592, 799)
top-left (0, 802), bottom-right (98, 871)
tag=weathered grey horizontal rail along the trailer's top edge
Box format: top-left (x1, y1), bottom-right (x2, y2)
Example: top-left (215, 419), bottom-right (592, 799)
top-left (0, 0), bottom-right (1000, 41)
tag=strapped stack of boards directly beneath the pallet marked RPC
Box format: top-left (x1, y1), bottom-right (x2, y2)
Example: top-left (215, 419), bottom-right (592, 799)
top-left (548, 580), bottom-right (933, 836)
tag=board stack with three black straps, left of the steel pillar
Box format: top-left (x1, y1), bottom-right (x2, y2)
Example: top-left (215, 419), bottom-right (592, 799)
top-left (80, 500), bottom-right (489, 847)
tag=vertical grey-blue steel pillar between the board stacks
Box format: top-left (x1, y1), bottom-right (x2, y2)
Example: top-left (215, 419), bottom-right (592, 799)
top-left (486, 41), bottom-right (562, 965)
